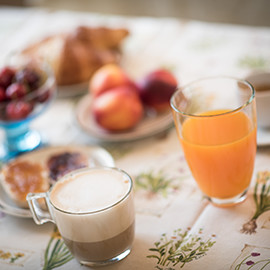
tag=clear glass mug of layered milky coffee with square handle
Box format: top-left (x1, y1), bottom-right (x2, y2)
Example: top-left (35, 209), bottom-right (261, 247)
top-left (27, 167), bottom-right (135, 266)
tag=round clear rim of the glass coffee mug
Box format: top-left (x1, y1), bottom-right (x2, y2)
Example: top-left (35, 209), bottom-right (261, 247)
top-left (49, 166), bottom-right (133, 216)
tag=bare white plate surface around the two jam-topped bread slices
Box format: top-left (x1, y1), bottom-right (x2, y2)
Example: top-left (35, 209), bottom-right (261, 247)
top-left (0, 145), bottom-right (115, 218)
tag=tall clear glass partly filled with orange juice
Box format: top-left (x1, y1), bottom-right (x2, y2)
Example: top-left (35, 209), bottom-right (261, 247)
top-left (171, 77), bottom-right (257, 206)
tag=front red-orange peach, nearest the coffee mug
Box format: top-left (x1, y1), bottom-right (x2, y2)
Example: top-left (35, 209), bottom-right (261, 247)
top-left (92, 85), bottom-right (144, 131)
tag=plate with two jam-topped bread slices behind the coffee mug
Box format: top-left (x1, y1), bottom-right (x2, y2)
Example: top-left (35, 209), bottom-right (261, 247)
top-left (0, 145), bottom-right (115, 218)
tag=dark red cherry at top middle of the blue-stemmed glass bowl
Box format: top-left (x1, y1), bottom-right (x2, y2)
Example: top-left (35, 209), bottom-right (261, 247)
top-left (16, 67), bottom-right (41, 91)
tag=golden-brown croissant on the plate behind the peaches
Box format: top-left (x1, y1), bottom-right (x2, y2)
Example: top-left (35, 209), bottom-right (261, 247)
top-left (22, 26), bottom-right (128, 85)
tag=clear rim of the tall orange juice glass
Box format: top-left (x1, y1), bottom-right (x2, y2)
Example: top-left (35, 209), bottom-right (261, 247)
top-left (170, 76), bottom-right (255, 118)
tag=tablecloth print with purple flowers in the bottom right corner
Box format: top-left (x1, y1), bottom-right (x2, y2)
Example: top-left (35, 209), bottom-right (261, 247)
top-left (230, 245), bottom-right (270, 270)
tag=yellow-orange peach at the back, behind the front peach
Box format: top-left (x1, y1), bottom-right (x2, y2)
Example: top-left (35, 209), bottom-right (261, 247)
top-left (89, 64), bottom-right (134, 97)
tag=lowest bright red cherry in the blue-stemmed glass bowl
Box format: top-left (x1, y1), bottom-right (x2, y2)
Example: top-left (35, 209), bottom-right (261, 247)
top-left (6, 100), bottom-right (33, 120)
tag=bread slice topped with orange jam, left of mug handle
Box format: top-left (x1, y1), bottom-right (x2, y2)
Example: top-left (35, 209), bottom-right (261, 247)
top-left (1, 160), bottom-right (49, 208)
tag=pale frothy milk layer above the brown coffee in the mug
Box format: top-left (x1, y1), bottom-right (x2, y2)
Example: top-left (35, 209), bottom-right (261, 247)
top-left (48, 168), bottom-right (135, 242)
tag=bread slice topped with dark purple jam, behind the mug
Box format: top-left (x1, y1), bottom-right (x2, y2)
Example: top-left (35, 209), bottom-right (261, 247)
top-left (47, 152), bottom-right (89, 181)
